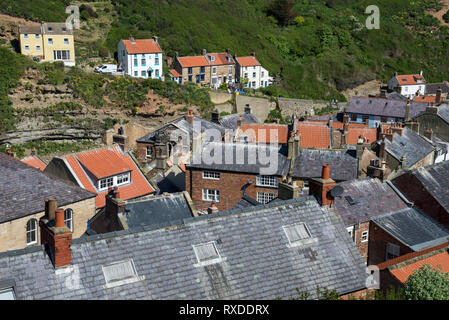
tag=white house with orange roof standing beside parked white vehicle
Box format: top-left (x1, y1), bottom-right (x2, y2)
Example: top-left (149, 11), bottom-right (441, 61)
top-left (117, 37), bottom-right (164, 80)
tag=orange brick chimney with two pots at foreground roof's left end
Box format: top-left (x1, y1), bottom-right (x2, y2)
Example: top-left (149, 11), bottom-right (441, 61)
top-left (39, 202), bottom-right (72, 268)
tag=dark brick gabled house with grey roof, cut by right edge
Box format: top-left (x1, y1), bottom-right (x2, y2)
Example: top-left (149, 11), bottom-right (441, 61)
top-left (392, 161), bottom-right (449, 228)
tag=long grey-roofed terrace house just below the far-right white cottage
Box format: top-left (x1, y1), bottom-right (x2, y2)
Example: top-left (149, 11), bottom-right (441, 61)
top-left (345, 97), bottom-right (427, 128)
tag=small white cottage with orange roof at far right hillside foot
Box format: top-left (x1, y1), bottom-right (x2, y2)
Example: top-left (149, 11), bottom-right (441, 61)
top-left (388, 71), bottom-right (426, 99)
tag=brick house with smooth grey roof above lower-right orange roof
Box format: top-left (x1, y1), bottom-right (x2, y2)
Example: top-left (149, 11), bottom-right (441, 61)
top-left (368, 208), bottom-right (449, 265)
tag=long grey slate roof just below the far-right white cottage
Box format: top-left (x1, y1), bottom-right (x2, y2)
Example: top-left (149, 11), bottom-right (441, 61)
top-left (346, 97), bottom-right (427, 118)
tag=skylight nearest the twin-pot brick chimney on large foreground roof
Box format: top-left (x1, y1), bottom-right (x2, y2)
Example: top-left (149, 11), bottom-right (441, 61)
top-left (101, 259), bottom-right (145, 288)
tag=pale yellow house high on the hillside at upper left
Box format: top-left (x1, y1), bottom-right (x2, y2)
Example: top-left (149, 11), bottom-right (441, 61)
top-left (19, 23), bottom-right (75, 66)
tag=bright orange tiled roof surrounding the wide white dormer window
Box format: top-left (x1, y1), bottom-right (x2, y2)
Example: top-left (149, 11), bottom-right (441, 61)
top-left (65, 147), bottom-right (154, 208)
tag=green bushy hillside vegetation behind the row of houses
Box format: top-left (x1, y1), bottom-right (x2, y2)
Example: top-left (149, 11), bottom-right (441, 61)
top-left (0, 0), bottom-right (449, 100)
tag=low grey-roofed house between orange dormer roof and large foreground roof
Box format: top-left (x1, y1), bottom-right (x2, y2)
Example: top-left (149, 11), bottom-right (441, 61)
top-left (87, 189), bottom-right (198, 234)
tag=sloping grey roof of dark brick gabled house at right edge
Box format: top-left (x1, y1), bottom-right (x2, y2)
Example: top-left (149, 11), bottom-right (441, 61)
top-left (403, 161), bottom-right (449, 212)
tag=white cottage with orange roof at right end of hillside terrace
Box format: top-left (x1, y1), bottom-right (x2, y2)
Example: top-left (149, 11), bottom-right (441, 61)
top-left (235, 53), bottom-right (273, 89)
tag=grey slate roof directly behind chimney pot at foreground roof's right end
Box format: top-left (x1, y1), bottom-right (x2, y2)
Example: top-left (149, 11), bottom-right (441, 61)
top-left (293, 149), bottom-right (358, 181)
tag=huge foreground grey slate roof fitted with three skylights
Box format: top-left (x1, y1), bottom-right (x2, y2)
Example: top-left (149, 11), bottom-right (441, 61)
top-left (0, 197), bottom-right (366, 300)
